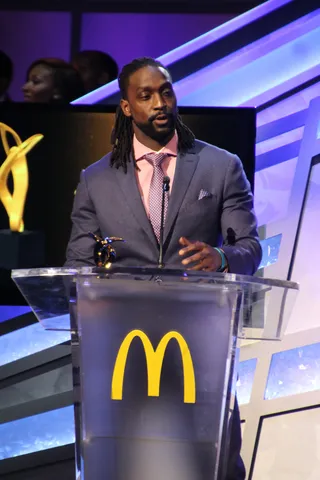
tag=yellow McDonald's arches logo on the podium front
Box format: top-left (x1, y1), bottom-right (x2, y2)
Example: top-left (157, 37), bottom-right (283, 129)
top-left (111, 330), bottom-right (196, 403)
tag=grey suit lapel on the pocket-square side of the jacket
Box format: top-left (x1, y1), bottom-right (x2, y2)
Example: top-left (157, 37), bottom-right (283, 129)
top-left (164, 150), bottom-right (199, 242)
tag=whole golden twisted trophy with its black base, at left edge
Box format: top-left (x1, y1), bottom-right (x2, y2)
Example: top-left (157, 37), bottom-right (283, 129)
top-left (0, 123), bottom-right (44, 270)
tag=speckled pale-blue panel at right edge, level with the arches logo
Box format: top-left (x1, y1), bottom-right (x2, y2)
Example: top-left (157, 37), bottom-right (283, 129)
top-left (265, 343), bottom-right (320, 400)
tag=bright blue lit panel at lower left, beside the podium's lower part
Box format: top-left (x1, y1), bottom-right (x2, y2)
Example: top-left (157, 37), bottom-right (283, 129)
top-left (0, 406), bottom-right (75, 460)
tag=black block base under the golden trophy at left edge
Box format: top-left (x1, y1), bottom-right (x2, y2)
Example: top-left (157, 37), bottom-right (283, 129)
top-left (0, 230), bottom-right (45, 270)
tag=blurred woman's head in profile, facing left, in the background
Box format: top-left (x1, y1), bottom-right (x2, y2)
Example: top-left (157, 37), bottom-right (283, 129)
top-left (22, 58), bottom-right (85, 104)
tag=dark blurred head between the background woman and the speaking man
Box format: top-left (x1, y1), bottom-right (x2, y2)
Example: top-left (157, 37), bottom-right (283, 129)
top-left (72, 50), bottom-right (119, 93)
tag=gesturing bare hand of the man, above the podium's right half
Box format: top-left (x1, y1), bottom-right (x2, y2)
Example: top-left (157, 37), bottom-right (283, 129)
top-left (179, 237), bottom-right (221, 272)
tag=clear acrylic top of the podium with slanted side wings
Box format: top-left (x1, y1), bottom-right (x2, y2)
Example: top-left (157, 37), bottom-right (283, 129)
top-left (12, 266), bottom-right (299, 339)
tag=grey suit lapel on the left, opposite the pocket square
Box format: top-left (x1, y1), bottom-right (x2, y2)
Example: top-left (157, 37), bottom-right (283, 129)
top-left (115, 159), bottom-right (158, 249)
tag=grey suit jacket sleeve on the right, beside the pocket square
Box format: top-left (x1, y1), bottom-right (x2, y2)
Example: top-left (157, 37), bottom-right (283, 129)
top-left (221, 155), bottom-right (262, 275)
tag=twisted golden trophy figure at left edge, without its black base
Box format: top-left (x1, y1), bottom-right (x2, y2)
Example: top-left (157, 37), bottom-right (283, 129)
top-left (0, 123), bottom-right (43, 232)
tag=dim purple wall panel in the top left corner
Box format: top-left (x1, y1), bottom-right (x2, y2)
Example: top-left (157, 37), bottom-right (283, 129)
top-left (0, 11), bottom-right (71, 101)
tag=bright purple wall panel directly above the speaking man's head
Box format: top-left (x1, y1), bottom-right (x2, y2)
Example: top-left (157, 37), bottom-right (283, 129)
top-left (81, 13), bottom-right (233, 68)
